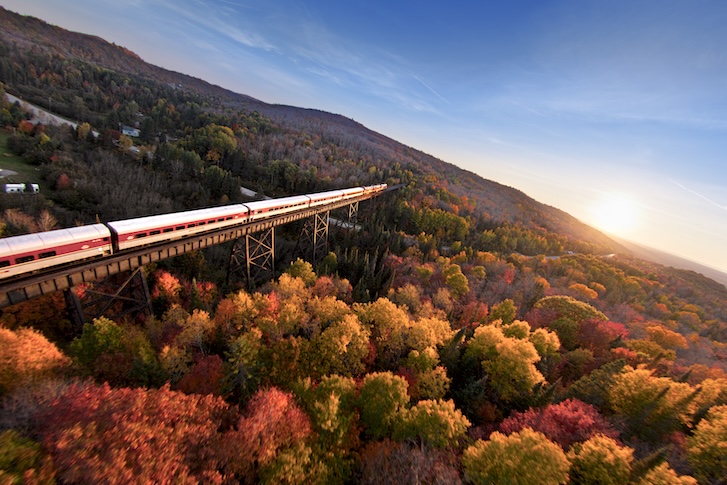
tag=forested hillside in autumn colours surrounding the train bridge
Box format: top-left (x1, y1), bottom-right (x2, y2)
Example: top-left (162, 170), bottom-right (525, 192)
top-left (0, 10), bottom-right (727, 484)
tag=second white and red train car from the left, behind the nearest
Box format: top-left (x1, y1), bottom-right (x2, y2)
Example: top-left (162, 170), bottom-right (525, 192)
top-left (106, 204), bottom-right (250, 251)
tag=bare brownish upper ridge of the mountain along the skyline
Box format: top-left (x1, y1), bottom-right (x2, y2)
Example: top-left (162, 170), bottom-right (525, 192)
top-left (0, 7), bottom-right (628, 252)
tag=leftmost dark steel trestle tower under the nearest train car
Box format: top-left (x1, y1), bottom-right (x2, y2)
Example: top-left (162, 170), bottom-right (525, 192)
top-left (64, 266), bottom-right (152, 331)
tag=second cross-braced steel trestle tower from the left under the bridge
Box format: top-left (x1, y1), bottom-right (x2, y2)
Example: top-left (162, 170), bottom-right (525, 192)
top-left (227, 226), bottom-right (275, 290)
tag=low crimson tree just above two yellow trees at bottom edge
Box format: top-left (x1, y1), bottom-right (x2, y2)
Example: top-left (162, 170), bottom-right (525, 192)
top-left (500, 399), bottom-right (618, 450)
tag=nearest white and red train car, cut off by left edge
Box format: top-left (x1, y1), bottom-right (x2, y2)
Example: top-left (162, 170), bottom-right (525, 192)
top-left (0, 224), bottom-right (112, 279)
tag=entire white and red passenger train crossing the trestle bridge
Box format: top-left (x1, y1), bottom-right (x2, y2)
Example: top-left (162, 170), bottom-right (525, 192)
top-left (0, 184), bottom-right (387, 281)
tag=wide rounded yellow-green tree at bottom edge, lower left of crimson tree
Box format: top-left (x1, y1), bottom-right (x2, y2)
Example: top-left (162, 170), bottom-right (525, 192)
top-left (462, 428), bottom-right (570, 485)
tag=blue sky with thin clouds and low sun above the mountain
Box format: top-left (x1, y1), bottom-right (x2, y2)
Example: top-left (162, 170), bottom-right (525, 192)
top-left (0, 0), bottom-right (727, 271)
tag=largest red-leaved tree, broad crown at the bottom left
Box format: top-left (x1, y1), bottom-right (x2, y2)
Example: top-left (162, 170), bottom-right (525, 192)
top-left (38, 383), bottom-right (231, 484)
